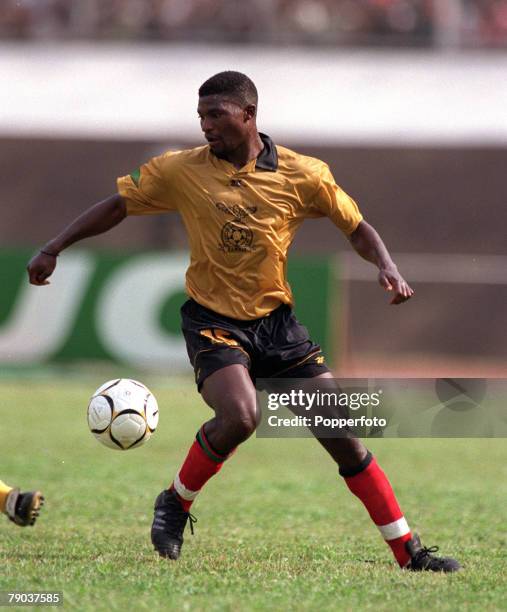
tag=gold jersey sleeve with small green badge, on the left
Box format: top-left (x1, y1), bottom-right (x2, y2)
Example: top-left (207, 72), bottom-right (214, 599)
top-left (117, 151), bottom-right (178, 215)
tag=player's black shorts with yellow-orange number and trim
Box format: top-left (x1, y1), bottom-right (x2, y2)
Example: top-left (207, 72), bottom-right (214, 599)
top-left (181, 299), bottom-right (329, 390)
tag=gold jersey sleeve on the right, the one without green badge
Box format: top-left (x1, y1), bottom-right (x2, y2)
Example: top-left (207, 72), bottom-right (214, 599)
top-left (312, 163), bottom-right (363, 236)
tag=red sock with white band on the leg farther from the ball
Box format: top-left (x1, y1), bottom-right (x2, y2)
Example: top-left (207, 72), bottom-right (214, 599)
top-left (340, 453), bottom-right (412, 567)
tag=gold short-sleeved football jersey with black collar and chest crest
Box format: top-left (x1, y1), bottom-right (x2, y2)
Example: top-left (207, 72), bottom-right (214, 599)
top-left (118, 134), bottom-right (362, 320)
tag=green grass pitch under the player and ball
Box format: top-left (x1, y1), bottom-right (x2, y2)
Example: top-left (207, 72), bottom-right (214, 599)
top-left (0, 377), bottom-right (507, 611)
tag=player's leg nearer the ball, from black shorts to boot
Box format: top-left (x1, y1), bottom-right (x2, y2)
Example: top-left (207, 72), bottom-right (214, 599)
top-left (151, 300), bottom-right (255, 559)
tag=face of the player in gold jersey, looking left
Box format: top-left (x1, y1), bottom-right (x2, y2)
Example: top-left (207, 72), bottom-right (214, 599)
top-left (197, 96), bottom-right (255, 156)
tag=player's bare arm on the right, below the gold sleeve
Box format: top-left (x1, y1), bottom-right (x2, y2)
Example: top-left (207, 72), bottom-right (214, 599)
top-left (349, 221), bottom-right (414, 304)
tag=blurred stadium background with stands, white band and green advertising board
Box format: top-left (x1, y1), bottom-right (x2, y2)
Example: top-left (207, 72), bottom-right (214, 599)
top-left (0, 0), bottom-right (507, 377)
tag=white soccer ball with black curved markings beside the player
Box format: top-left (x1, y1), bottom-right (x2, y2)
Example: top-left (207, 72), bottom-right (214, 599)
top-left (88, 378), bottom-right (158, 450)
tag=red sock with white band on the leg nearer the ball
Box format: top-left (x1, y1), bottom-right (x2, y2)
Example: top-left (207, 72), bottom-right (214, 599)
top-left (170, 426), bottom-right (229, 512)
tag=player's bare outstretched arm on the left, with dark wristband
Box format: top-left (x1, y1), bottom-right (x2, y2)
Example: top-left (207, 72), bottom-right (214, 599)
top-left (27, 194), bottom-right (127, 285)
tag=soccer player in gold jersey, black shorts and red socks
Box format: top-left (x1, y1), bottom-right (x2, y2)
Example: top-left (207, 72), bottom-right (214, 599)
top-left (28, 71), bottom-right (459, 572)
